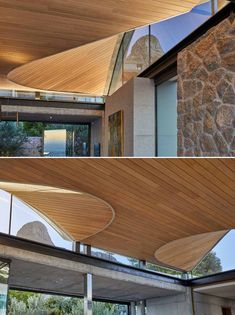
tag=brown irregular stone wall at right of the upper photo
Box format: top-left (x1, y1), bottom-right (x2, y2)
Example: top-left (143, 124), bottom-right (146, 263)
top-left (178, 18), bottom-right (235, 156)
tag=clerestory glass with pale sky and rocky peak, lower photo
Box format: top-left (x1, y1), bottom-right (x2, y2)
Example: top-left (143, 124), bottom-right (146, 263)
top-left (11, 197), bottom-right (72, 250)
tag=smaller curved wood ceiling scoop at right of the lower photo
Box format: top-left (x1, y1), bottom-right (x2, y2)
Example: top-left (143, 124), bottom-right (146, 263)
top-left (155, 231), bottom-right (228, 271)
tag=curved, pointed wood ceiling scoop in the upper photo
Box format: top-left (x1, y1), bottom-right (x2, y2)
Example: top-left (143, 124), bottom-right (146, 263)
top-left (8, 36), bottom-right (119, 96)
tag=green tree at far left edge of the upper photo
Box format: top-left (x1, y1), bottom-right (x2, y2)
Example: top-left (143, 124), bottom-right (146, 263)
top-left (0, 121), bottom-right (27, 156)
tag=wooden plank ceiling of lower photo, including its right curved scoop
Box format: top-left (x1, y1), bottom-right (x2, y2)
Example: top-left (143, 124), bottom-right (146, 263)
top-left (0, 158), bottom-right (235, 269)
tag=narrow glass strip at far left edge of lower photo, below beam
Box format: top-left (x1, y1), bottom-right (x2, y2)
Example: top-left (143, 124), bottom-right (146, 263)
top-left (0, 261), bottom-right (9, 315)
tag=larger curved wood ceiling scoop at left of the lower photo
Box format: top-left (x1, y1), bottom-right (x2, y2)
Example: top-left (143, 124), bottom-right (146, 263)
top-left (0, 182), bottom-right (114, 241)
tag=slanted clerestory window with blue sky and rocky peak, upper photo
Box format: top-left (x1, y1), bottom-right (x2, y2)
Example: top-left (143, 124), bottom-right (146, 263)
top-left (109, 0), bottom-right (211, 95)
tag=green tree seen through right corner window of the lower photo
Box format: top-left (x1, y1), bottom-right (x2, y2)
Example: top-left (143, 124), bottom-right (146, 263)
top-left (192, 252), bottom-right (222, 276)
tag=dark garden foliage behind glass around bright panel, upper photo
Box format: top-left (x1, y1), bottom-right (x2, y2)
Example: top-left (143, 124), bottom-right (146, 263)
top-left (0, 121), bottom-right (89, 157)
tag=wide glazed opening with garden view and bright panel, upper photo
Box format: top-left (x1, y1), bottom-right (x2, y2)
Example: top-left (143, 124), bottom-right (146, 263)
top-left (0, 122), bottom-right (90, 157)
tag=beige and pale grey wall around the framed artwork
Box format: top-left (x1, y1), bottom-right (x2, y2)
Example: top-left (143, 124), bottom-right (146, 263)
top-left (103, 78), bottom-right (155, 156)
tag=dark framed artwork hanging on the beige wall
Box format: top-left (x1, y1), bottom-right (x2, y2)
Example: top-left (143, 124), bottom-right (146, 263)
top-left (108, 110), bottom-right (124, 156)
